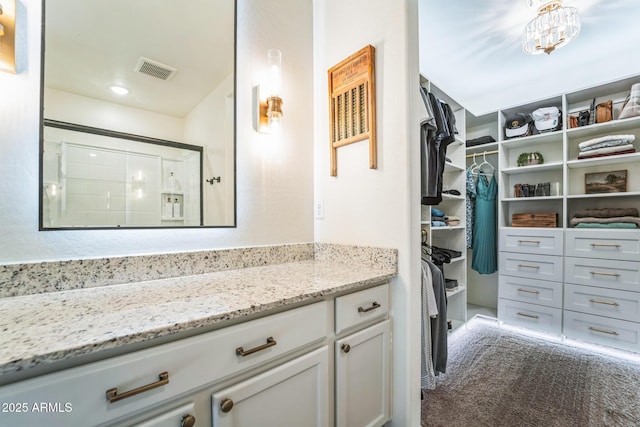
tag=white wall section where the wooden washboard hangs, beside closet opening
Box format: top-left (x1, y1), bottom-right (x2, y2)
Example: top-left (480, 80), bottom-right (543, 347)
top-left (314, 0), bottom-right (420, 426)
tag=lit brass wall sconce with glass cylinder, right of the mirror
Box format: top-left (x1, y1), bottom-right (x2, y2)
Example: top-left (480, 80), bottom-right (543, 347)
top-left (255, 49), bottom-right (282, 133)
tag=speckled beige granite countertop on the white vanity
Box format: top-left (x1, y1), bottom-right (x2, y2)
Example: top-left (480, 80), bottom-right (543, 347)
top-left (0, 260), bottom-right (396, 376)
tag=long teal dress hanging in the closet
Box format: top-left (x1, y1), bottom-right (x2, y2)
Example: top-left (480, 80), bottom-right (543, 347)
top-left (471, 174), bottom-right (498, 274)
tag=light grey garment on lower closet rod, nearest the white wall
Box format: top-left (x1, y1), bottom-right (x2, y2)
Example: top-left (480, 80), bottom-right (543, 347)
top-left (420, 260), bottom-right (438, 390)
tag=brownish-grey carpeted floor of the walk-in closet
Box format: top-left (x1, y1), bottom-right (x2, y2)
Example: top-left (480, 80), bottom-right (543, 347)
top-left (422, 318), bottom-right (640, 427)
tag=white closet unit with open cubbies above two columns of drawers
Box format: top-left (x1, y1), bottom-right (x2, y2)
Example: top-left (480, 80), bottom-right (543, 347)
top-left (467, 76), bottom-right (640, 352)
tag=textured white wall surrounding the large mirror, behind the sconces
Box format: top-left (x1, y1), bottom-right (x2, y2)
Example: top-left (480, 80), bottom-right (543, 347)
top-left (0, 0), bottom-right (313, 263)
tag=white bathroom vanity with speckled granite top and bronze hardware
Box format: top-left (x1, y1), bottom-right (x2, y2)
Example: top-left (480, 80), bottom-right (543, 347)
top-left (0, 245), bottom-right (397, 426)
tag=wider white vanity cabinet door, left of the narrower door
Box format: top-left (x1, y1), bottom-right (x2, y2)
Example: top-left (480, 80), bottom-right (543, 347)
top-left (212, 347), bottom-right (329, 427)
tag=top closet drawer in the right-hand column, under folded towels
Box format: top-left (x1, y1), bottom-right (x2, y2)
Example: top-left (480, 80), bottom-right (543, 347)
top-left (566, 229), bottom-right (640, 261)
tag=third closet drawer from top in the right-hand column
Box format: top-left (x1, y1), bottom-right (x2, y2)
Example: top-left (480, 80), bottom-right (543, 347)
top-left (564, 283), bottom-right (640, 322)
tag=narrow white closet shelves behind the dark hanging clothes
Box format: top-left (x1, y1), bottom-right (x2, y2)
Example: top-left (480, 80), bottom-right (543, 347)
top-left (421, 77), bottom-right (467, 330)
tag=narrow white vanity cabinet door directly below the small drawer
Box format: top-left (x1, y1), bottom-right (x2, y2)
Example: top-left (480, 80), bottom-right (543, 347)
top-left (335, 320), bottom-right (391, 427)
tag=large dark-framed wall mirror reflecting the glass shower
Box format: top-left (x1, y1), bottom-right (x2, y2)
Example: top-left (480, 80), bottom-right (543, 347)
top-left (40, 0), bottom-right (236, 230)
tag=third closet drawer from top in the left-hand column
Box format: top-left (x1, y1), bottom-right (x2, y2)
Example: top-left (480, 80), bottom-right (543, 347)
top-left (498, 274), bottom-right (562, 308)
